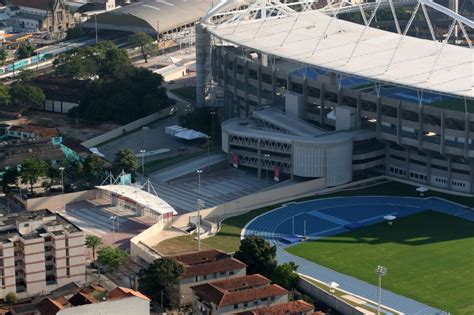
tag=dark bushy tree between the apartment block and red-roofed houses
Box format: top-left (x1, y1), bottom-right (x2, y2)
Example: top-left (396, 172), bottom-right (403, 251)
top-left (138, 257), bottom-right (184, 309)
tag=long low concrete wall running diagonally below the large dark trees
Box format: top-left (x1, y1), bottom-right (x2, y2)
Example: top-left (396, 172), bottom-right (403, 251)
top-left (81, 106), bottom-right (176, 148)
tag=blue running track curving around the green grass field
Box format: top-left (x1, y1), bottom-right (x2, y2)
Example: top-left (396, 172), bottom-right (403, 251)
top-left (242, 196), bottom-right (474, 315)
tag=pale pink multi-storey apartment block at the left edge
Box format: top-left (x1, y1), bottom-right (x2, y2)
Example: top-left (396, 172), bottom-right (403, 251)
top-left (0, 209), bottom-right (85, 298)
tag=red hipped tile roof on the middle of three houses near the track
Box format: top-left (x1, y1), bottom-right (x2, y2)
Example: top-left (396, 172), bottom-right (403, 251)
top-left (191, 275), bottom-right (288, 306)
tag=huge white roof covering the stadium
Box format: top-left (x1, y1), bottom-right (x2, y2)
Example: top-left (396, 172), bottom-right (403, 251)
top-left (207, 11), bottom-right (474, 98)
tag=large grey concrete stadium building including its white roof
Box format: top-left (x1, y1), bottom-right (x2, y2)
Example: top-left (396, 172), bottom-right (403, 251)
top-left (196, 1), bottom-right (474, 193)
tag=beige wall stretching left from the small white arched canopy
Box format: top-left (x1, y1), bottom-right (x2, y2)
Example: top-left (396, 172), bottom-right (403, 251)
top-left (24, 189), bottom-right (98, 211)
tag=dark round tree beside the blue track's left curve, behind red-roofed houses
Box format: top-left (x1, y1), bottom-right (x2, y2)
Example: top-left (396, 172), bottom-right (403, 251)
top-left (234, 236), bottom-right (277, 277)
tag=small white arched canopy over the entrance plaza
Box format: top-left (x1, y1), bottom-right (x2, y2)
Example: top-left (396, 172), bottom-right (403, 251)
top-left (97, 185), bottom-right (178, 215)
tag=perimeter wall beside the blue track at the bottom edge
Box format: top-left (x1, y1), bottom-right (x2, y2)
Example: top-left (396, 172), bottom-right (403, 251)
top-left (296, 278), bottom-right (364, 315)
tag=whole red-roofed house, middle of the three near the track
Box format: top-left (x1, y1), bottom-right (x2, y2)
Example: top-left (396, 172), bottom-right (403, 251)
top-left (191, 274), bottom-right (288, 315)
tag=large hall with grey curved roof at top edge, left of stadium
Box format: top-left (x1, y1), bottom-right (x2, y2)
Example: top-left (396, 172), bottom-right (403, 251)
top-left (82, 0), bottom-right (213, 34)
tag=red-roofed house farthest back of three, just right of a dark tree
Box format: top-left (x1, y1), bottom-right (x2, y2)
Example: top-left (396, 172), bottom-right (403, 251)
top-left (173, 249), bottom-right (247, 305)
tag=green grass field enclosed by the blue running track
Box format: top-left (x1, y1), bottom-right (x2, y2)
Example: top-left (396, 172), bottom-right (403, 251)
top-left (288, 211), bottom-right (474, 314)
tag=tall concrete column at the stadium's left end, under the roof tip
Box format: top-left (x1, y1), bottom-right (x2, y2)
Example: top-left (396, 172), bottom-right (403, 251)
top-left (196, 23), bottom-right (210, 107)
